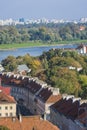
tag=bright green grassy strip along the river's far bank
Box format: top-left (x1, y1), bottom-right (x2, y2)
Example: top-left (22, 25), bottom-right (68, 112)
top-left (0, 40), bottom-right (87, 50)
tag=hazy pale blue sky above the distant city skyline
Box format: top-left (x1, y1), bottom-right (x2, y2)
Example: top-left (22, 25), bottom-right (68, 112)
top-left (0, 0), bottom-right (87, 20)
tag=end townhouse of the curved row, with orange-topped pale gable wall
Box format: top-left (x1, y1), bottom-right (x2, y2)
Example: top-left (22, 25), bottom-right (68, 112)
top-left (35, 87), bottom-right (62, 120)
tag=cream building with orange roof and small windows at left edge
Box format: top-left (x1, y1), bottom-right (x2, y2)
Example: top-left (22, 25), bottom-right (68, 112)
top-left (0, 90), bottom-right (16, 117)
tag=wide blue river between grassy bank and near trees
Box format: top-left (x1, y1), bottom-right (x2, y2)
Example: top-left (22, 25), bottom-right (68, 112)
top-left (0, 44), bottom-right (77, 62)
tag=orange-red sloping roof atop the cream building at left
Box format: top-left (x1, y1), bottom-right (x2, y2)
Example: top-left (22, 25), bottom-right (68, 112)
top-left (0, 90), bottom-right (16, 104)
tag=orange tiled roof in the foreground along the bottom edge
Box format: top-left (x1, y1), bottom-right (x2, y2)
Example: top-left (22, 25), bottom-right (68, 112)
top-left (0, 116), bottom-right (59, 130)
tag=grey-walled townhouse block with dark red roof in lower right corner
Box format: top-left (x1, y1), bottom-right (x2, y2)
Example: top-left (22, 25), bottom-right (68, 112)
top-left (50, 95), bottom-right (87, 130)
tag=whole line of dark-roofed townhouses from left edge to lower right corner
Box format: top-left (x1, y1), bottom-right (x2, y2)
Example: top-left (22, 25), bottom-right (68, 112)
top-left (0, 73), bottom-right (87, 130)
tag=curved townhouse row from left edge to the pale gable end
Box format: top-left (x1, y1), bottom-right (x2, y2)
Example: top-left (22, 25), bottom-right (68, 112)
top-left (1, 73), bottom-right (61, 119)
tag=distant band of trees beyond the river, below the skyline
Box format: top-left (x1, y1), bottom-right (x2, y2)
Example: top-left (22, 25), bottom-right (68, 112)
top-left (0, 23), bottom-right (87, 44)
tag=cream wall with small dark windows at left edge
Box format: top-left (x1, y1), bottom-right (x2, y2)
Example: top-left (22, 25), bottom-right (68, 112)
top-left (0, 103), bottom-right (16, 117)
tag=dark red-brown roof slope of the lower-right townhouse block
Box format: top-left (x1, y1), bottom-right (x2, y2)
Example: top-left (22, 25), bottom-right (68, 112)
top-left (51, 98), bottom-right (79, 120)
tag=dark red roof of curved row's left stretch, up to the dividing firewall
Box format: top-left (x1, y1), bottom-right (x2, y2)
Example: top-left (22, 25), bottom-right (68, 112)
top-left (1, 75), bottom-right (42, 94)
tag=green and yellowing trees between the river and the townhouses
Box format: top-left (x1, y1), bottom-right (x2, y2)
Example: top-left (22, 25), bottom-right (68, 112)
top-left (1, 49), bottom-right (87, 99)
